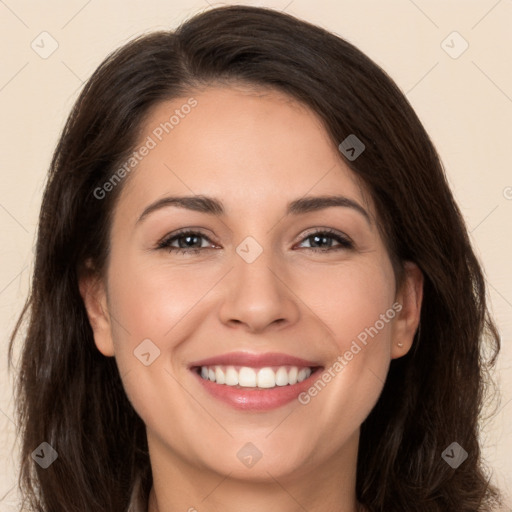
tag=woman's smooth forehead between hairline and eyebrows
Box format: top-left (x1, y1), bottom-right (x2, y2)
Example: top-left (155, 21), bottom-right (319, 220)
top-left (114, 86), bottom-right (373, 224)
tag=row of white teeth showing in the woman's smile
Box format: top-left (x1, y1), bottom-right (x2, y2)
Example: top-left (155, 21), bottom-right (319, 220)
top-left (201, 366), bottom-right (312, 389)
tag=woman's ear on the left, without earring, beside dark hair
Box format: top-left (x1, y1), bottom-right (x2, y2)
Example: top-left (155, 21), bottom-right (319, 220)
top-left (79, 273), bottom-right (114, 356)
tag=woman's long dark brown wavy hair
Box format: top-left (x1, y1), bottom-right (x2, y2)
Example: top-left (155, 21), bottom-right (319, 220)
top-left (9, 6), bottom-right (500, 512)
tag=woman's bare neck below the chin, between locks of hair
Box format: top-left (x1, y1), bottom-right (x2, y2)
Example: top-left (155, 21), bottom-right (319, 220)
top-left (148, 431), bottom-right (365, 512)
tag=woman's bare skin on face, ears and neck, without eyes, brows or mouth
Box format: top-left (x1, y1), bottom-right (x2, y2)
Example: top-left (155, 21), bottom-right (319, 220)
top-left (80, 86), bottom-right (423, 512)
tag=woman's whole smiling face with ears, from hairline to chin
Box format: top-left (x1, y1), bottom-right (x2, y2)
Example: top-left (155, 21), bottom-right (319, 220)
top-left (82, 87), bottom-right (421, 486)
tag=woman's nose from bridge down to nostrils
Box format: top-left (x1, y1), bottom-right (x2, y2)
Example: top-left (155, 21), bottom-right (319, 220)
top-left (221, 236), bottom-right (298, 331)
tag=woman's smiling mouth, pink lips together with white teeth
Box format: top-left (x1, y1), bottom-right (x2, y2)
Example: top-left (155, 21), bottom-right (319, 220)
top-left (189, 352), bottom-right (323, 411)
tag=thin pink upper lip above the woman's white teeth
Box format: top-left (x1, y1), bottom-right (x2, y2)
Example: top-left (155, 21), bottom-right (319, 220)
top-left (190, 352), bottom-right (320, 368)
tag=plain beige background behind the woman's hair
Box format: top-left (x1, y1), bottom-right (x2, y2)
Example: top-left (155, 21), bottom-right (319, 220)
top-left (0, 0), bottom-right (512, 506)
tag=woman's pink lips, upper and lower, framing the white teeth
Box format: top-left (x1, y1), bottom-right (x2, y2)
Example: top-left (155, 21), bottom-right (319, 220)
top-left (189, 352), bottom-right (323, 411)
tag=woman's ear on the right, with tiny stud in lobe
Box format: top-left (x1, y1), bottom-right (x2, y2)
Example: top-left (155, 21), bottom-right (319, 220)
top-left (391, 261), bottom-right (423, 359)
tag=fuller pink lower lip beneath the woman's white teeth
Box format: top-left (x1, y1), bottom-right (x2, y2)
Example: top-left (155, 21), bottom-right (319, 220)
top-left (192, 368), bottom-right (321, 411)
